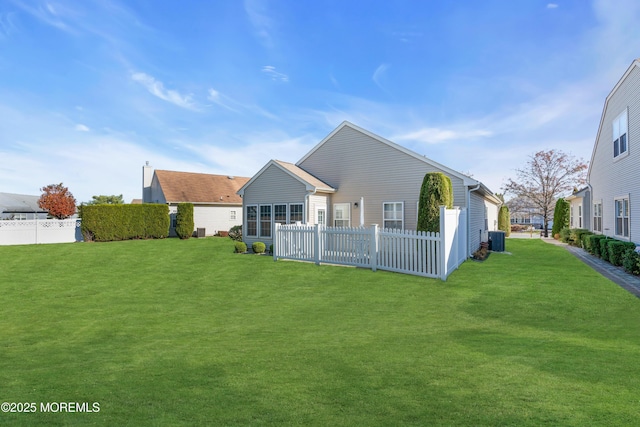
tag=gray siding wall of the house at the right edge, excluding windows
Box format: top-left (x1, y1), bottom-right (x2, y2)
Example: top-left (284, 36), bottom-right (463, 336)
top-left (589, 67), bottom-right (640, 242)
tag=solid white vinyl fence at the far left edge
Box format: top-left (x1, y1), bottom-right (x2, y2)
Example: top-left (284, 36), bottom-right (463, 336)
top-left (0, 219), bottom-right (82, 245)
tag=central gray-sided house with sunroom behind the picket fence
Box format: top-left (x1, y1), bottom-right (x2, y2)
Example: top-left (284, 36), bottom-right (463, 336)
top-left (238, 122), bottom-right (501, 254)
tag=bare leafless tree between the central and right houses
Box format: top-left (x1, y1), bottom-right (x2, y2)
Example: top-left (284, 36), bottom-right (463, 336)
top-left (502, 150), bottom-right (587, 237)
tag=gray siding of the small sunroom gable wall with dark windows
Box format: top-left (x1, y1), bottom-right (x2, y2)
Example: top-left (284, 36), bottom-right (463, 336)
top-left (242, 165), bottom-right (307, 248)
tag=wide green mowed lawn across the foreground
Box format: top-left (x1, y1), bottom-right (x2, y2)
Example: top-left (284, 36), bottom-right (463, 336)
top-left (0, 238), bottom-right (640, 426)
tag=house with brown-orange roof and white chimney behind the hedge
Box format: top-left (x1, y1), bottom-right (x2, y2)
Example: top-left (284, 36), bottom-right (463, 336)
top-left (142, 164), bottom-right (249, 236)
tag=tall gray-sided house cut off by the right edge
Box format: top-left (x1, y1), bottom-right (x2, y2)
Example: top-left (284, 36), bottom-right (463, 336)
top-left (587, 59), bottom-right (640, 242)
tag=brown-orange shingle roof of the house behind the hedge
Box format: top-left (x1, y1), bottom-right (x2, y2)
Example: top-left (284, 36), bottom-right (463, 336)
top-left (154, 170), bottom-right (249, 204)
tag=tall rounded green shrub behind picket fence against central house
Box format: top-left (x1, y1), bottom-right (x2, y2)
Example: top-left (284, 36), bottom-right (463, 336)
top-left (417, 172), bottom-right (453, 232)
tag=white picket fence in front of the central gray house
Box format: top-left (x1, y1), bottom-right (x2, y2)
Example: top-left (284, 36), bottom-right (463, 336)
top-left (273, 207), bottom-right (467, 280)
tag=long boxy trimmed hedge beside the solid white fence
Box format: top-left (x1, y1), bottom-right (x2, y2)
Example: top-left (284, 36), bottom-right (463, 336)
top-left (81, 203), bottom-right (170, 242)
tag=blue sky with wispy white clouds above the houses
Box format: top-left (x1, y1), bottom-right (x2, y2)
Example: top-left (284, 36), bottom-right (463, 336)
top-left (0, 0), bottom-right (640, 202)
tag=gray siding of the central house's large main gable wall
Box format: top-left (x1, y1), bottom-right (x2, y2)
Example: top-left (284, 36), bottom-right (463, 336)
top-left (299, 127), bottom-right (466, 229)
